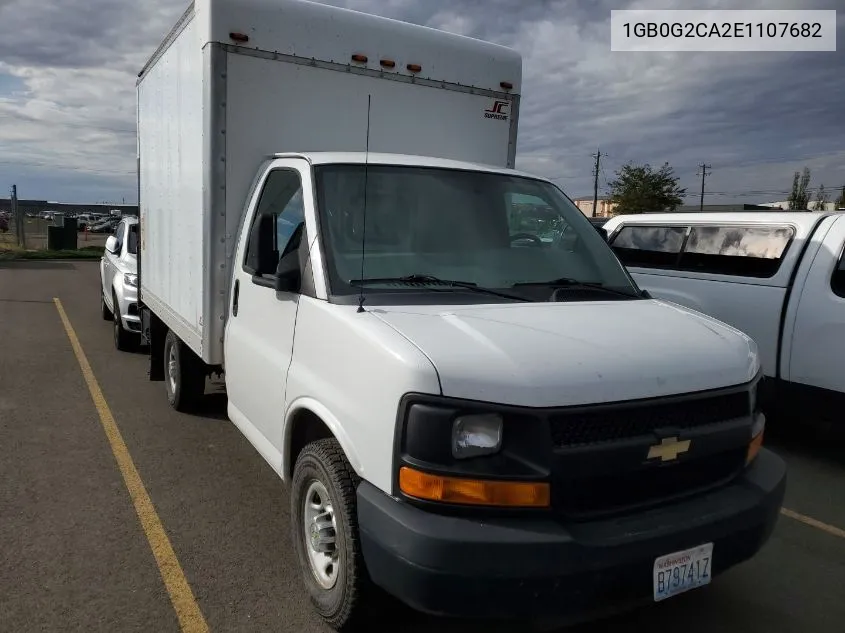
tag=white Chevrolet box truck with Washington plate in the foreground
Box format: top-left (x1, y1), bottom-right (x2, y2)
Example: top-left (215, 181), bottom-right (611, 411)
top-left (138, 0), bottom-right (785, 629)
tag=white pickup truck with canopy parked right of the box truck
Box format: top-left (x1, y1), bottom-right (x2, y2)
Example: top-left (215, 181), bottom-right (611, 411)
top-left (604, 211), bottom-right (845, 422)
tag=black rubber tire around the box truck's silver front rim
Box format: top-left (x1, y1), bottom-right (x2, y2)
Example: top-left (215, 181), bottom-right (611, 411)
top-left (290, 438), bottom-right (370, 631)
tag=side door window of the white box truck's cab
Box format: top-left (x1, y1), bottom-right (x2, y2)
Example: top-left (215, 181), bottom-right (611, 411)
top-left (244, 169), bottom-right (305, 272)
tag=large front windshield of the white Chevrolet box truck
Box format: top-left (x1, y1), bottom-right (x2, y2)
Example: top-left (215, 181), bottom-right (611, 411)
top-left (316, 165), bottom-right (638, 300)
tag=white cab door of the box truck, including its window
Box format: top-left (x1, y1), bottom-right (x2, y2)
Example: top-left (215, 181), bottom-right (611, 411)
top-left (224, 159), bottom-right (311, 468)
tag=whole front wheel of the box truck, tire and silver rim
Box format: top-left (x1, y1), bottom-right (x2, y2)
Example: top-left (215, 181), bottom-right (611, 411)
top-left (290, 438), bottom-right (369, 631)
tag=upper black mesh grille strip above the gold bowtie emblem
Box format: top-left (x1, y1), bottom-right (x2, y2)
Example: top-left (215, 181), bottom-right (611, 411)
top-left (549, 391), bottom-right (750, 448)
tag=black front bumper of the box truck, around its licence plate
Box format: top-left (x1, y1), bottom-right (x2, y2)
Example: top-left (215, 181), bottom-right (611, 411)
top-left (358, 450), bottom-right (786, 619)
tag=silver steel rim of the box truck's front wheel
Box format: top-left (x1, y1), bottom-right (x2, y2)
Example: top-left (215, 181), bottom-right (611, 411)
top-left (302, 480), bottom-right (338, 589)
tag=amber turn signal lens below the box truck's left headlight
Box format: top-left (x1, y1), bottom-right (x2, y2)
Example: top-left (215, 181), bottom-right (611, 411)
top-left (399, 466), bottom-right (551, 508)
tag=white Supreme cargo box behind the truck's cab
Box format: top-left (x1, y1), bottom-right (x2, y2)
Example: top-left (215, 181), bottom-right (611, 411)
top-left (138, 0), bottom-right (522, 365)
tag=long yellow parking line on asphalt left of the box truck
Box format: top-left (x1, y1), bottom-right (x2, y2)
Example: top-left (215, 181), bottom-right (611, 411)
top-left (53, 298), bottom-right (208, 633)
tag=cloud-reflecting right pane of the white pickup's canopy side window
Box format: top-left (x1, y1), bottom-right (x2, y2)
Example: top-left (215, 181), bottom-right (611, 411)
top-left (678, 226), bottom-right (795, 277)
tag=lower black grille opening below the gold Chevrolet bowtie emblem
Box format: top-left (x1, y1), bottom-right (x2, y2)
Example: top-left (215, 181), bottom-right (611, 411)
top-left (552, 447), bottom-right (746, 518)
